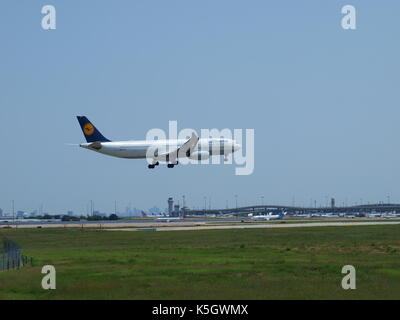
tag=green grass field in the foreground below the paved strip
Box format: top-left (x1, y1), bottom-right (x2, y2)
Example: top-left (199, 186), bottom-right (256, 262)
top-left (0, 225), bottom-right (400, 299)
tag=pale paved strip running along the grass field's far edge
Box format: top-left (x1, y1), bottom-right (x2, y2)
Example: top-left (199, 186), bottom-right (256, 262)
top-left (106, 221), bottom-right (400, 231)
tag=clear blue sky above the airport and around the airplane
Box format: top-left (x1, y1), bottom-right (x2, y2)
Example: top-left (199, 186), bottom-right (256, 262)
top-left (0, 0), bottom-right (400, 213)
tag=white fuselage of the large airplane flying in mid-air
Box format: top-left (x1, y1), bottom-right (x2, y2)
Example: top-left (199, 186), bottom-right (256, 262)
top-left (80, 138), bottom-right (240, 159)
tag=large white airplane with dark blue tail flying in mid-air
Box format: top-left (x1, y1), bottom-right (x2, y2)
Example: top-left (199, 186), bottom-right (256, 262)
top-left (77, 116), bottom-right (241, 169)
